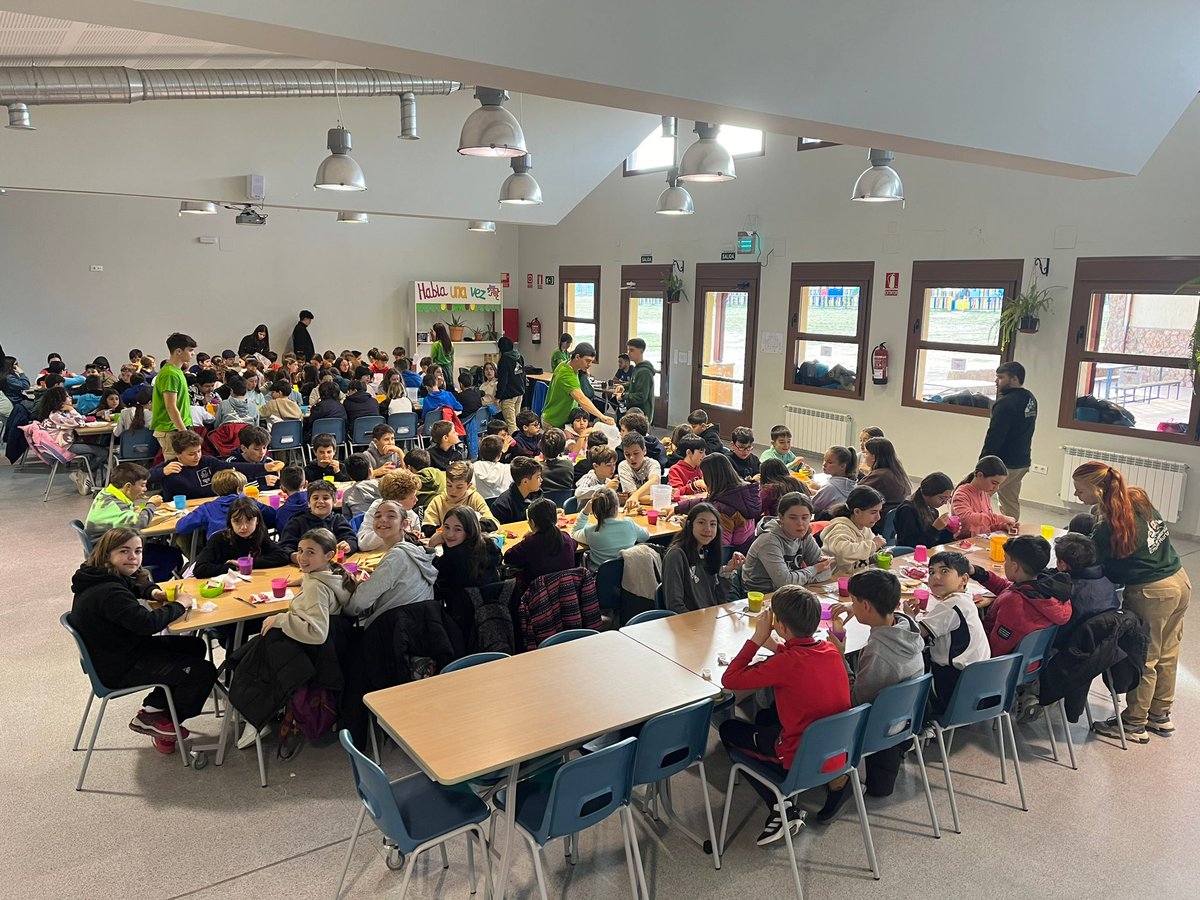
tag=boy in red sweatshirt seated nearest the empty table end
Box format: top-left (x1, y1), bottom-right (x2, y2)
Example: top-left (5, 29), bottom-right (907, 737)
top-left (720, 584), bottom-right (850, 846)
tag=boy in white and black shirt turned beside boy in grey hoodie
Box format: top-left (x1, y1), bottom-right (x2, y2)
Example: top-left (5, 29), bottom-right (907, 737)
top-left (905, 551), bottom-right (991, 714)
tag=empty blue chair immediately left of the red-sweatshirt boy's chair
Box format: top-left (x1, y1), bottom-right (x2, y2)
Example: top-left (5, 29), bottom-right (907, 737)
top-left (634, 696), bottom-right (721, 869)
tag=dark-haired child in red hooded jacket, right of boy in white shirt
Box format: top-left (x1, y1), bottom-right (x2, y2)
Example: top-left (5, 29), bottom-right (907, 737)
top-left (971, 534), bottom-right (1070, 656)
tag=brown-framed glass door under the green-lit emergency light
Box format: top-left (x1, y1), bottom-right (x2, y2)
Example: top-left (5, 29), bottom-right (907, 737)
top-left (692, 264), bottom-right (760, 437)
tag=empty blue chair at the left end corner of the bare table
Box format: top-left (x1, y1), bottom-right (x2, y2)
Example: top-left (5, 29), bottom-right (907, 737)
top-left (335, 728), bottom-right (492, 898)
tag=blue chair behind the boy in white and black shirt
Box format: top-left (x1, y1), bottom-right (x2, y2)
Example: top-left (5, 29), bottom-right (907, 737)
top-left (932, 653), bottom-right (1030, 834)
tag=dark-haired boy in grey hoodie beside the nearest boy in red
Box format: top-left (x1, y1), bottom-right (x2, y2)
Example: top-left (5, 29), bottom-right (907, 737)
top-left (817, 569), bottom-right (925, 822)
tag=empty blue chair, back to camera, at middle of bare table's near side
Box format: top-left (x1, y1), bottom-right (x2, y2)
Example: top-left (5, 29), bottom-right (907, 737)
top-left (496, 738), bottom-right (650, 898)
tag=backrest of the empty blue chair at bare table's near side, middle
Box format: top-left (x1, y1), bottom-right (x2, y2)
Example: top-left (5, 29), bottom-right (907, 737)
top-left (534, 738), bottom-right (637, 844)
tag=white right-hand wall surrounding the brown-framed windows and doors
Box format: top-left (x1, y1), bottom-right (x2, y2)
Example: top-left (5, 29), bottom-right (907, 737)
top-left (517, 101), bottom-right (1200, 534)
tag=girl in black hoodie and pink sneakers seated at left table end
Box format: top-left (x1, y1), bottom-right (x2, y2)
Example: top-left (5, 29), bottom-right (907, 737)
top-left (68, 528), bottom-right (217, 754)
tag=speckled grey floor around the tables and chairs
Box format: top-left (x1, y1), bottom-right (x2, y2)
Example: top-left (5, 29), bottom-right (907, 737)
top-left (7, 464), bottom-right (1200, 900)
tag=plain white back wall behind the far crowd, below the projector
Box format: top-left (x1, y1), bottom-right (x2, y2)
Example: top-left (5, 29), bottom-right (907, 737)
top-left (0, 191), bottom-right (517, 372)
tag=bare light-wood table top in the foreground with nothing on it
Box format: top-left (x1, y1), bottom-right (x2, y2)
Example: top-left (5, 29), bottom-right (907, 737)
top-left (366, 631), bottom-right (718, 785)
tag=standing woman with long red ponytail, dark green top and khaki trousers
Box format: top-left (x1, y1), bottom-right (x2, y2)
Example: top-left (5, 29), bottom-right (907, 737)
top-left (1072, 461), bottom-right (1192, 744)
